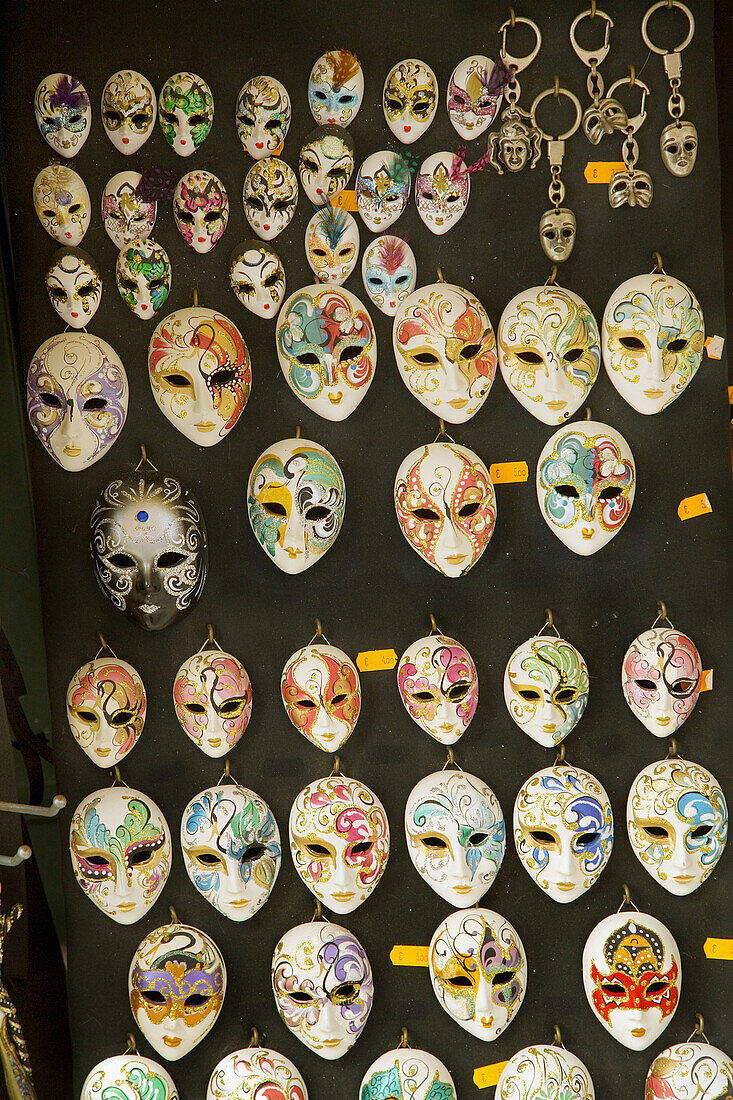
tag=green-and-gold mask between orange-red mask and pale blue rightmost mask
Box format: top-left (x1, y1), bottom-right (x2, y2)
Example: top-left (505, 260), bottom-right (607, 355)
top-left (496, 284), bottom-right (601, 424)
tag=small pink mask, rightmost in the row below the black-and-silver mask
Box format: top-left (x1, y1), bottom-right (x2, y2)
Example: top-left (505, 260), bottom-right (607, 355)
top-left (621, 624), bottom-right (702, 737)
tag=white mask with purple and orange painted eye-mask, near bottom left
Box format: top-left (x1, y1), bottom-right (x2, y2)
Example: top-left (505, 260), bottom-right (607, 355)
top-left (128, 923), bottom-right (227, 1060)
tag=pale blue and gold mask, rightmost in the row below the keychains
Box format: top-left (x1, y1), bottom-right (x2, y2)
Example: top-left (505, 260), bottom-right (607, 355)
top-left (602, 272), bottom-right (705, 416)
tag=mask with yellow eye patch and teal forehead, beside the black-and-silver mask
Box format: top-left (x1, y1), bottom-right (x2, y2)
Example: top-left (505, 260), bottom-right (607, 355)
top-left (247, 439), bottom-right (346, 573)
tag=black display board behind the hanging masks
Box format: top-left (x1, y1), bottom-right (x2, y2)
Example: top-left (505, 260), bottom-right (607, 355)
top-left (0, 0), bottom-right (733, 1100)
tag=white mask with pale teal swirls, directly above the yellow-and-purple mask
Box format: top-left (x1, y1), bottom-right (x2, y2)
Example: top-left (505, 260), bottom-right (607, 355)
top-left (405, 770), bottom-right (506, 909)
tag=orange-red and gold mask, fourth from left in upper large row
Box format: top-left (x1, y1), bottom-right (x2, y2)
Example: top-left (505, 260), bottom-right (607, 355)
top-left (392, 283), bottom-right (496, 424)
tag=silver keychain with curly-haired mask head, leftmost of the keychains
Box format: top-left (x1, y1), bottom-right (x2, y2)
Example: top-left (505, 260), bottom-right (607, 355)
top-left (488, 8), bottom-right (543, 176)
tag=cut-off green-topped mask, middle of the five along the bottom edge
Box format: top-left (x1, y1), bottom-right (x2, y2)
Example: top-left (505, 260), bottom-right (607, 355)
top-left (359, 1046), bottom-right (456, 1100)
